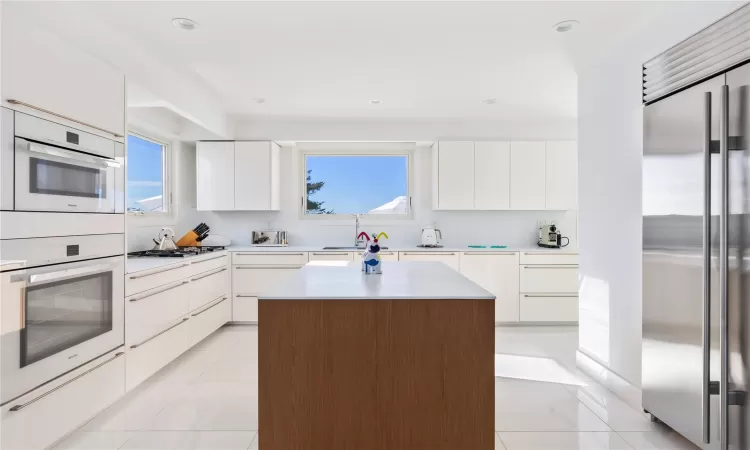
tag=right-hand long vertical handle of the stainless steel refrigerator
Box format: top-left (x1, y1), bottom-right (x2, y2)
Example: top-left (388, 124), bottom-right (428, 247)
top-left (719, 85), bottom-right (729, 450)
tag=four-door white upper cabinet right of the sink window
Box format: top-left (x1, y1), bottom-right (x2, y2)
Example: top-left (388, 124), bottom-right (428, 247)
top-left (432, 141), bottom-right (578, 211)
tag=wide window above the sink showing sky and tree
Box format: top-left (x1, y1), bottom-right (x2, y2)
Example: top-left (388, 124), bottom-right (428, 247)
top-left (301, 150), bottom-right (411, 219)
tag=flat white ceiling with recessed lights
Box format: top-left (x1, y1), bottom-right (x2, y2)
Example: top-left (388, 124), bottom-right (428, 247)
top-left (5, 1), bottom-right (736, 125)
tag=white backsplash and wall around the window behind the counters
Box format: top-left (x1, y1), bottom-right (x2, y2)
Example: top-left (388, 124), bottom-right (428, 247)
top-left (128, 143), bottom-right (578, 251)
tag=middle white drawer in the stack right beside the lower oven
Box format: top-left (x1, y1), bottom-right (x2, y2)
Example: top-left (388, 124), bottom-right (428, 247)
top-left (125, 280), bottom-right (193, 345)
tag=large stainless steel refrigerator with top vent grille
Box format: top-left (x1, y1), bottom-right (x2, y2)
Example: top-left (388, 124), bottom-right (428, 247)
top-left (642, 6), bottom-right (750, 450)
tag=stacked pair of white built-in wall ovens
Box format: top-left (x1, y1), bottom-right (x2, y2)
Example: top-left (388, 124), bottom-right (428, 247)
top-left (0, 109), bottom-right (125, 404)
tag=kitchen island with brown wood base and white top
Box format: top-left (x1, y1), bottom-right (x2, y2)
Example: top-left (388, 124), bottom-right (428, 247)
top-left (258, 261), bottom-right (495, 450)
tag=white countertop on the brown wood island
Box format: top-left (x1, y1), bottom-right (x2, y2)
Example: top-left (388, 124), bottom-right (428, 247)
top-left (258, 261), bottom-right (495, 300)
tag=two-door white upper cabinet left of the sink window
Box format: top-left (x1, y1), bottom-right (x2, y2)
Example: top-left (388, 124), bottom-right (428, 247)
top-left (196, 141), bottom-right (280, 211)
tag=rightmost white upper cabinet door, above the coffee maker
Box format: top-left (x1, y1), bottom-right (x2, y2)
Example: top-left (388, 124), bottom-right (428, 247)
top-left (546, 141), bottom-right (578, 210)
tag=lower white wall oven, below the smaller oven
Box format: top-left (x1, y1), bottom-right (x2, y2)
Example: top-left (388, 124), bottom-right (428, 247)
top-left (0, 234), bottom-right (125, 404)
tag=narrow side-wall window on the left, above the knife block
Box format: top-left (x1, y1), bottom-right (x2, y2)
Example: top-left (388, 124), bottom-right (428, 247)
top-left (126, 133), bottom-right (171, 214)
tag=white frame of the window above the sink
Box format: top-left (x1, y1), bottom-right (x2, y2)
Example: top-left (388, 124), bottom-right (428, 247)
top-left (298, 146), bottom-right (414, 222)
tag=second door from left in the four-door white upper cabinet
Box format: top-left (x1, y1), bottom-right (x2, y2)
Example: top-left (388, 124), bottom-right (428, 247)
top-left (474, 142), bottom-right (510, 210)
